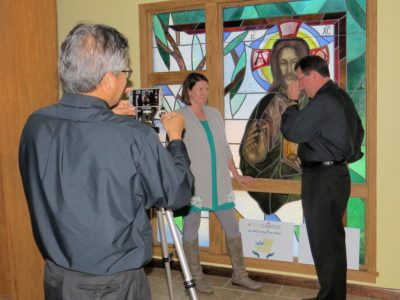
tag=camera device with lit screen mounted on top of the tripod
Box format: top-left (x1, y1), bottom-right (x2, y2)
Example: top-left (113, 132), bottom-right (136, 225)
top-left (129, 88), bottom-right (162, 133)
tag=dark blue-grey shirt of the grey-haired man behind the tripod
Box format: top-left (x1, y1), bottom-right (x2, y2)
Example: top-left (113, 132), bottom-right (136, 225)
top-left (19, 94), bottom-right (193, 275)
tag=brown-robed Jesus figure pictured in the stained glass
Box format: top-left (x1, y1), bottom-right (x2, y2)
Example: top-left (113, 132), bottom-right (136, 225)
top-left (239, 37), bottom-right (309, 214)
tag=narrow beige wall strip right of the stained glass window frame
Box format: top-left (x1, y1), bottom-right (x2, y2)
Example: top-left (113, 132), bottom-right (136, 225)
top-left (377, 0), bottom-right (400, 289)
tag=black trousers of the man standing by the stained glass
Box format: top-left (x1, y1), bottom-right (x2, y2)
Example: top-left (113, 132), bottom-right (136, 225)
top-left (301, 164), bottom-right (350, 300)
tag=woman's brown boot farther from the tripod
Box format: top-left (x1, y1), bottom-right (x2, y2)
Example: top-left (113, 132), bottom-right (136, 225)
top-left (226, 236), bottom-right (263, 291)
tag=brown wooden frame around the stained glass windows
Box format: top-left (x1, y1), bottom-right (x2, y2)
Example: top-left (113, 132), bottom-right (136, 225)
top-left (139, 0), bottom-right (378, 283)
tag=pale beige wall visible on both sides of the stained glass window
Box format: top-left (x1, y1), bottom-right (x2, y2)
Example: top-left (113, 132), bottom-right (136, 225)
top-left (57, 0), bottom-right (400, 289)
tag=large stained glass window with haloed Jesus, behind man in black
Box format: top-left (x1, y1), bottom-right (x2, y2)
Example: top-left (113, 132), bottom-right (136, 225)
top-left (223, 0), bottom-right (367, 263)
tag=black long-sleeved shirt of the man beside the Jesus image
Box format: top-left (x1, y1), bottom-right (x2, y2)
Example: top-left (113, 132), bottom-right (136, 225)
top-left (281, 81), bottom-right (364, 162)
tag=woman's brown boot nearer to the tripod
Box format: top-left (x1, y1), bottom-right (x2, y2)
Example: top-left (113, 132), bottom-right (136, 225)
top-left (183, 239), bottom-right (214, 294)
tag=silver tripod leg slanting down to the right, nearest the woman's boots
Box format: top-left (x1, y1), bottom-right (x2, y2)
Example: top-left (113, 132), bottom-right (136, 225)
top-left (161, 208), bottom-right (197, 300)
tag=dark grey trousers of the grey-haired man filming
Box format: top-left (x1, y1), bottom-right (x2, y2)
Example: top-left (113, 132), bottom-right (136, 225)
top-left (44, 260), bottom-right (151, 300)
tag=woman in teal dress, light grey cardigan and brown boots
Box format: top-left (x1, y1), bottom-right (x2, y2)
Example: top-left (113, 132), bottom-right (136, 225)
top-left (178, 73), bottom-right (262, 293)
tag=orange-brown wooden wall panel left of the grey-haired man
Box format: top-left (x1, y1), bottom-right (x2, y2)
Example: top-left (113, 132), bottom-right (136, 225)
top-left (0, 0), bottom-right (58, 300)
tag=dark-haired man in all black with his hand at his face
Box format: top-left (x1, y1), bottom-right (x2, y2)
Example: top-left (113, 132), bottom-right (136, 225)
top-left (281, 56), bottom-right (364, 300)
